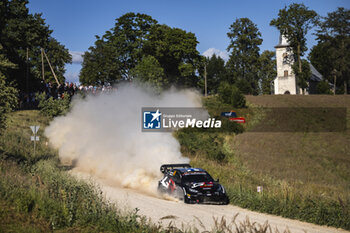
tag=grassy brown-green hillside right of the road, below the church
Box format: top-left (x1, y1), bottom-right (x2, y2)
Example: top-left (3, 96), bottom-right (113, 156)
top-left (179, 95), bottom-right (350, 229)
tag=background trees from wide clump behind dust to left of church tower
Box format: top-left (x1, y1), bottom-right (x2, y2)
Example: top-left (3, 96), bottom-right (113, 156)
top-left (80, 13), bottom-right (276, 94)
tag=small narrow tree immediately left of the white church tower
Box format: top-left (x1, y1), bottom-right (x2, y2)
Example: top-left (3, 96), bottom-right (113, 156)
top-left (258, 50), bottom-right (277, 94)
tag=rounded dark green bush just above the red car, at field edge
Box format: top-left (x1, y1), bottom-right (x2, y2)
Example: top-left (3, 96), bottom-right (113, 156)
top-left (218, 82), bottom-right (246, 108)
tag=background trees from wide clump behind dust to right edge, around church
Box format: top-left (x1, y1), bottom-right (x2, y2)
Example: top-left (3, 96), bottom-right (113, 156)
top-left (80, 3), bottom-right (350, 95)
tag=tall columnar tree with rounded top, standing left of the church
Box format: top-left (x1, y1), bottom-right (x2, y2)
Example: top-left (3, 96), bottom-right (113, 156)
top-left (226, 18), bottom-right (262, 94)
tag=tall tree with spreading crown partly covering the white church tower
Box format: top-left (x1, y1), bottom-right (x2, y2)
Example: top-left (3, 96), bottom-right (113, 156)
top-left (270, 3), bottom-right (318, 93)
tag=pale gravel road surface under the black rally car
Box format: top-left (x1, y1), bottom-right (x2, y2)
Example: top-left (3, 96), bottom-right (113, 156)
top-left (75, 173), bottom-right (348, 233)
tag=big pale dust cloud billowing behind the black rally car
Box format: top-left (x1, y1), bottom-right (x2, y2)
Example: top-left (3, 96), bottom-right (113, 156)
top-left (45, 85), bottom-right (201, 194)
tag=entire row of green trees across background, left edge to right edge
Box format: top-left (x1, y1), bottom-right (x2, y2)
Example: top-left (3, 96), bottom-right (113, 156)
top-left (0, 0), bottom-right (350, 131)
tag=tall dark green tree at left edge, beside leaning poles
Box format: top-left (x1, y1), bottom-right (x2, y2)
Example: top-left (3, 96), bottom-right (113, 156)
top-left (0, 0), bottom-right (71, 91)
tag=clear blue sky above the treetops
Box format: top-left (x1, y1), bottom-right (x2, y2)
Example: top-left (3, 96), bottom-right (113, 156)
top-left (27, 0), bottom-right (350, 82)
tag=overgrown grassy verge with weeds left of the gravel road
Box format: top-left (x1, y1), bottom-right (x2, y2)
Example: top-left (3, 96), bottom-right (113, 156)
top-left (0, 111), bottom-right (161, 232)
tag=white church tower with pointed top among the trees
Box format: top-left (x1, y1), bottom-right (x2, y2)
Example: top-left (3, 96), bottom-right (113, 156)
top-left (274, 34), bottom-right (299, 95)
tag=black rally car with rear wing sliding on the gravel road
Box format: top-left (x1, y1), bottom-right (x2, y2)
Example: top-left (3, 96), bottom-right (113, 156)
top-left (158, 164), bottom-right (229, 205)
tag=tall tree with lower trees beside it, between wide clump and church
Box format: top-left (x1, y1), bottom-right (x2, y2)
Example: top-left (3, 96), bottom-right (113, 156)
top-left (199, 18), bottom-right (276, 95)
